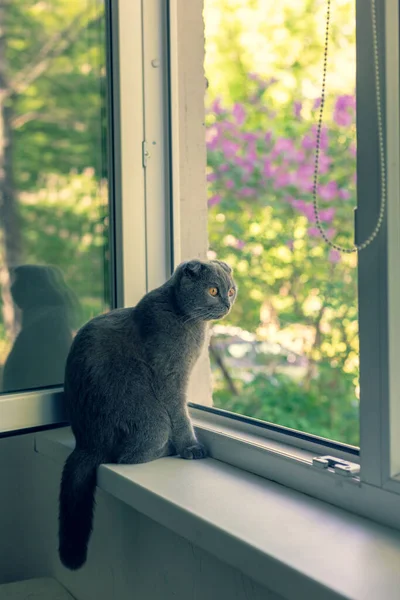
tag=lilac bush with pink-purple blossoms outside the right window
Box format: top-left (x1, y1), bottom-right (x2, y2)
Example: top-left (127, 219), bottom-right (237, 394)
top-left (206, 74), bottom-right (358, 437)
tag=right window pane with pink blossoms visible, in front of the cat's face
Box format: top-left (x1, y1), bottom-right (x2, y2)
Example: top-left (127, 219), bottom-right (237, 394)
top-left (204, 0), bottom-right (359, 445)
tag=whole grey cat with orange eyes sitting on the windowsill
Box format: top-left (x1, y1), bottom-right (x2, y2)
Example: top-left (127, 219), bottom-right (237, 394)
top-left (59, 260), bottom-right (237, 569)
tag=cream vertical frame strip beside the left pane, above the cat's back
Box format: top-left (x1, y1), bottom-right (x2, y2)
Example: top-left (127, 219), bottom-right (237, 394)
top-left (113, 0), bottom-right (146, 306)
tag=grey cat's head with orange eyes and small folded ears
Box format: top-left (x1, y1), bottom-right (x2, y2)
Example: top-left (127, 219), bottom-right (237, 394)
top-left (175, 260), bottom-right (237, 321)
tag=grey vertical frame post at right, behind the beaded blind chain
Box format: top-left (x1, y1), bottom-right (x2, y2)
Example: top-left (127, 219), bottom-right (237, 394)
top-left (356, 0), bottom-right (388, 486)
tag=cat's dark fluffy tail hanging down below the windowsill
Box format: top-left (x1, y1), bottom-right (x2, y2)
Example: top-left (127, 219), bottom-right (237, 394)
top-left (58, 448), bottom-right (102, 570)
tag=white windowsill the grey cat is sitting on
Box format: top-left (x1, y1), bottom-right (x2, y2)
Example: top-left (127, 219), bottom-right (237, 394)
top-left (35, 428), bottom-right (400, 600)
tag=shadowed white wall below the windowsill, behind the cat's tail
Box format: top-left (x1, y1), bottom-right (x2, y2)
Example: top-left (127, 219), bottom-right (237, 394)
top-left (0, 435), bottom-right (279, 600)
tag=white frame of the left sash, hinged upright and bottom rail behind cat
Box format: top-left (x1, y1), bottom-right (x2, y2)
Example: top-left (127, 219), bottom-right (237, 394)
top-left (0, 0), bottom-right (172, 437)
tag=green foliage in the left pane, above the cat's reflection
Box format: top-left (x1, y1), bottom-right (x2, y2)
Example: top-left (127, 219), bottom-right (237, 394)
top-left (0, 0), bottom-right (110, 360)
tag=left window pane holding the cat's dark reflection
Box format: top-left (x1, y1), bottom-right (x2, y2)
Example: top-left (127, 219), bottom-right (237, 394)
top-left (0, 0), bottom-right (110, 392)
